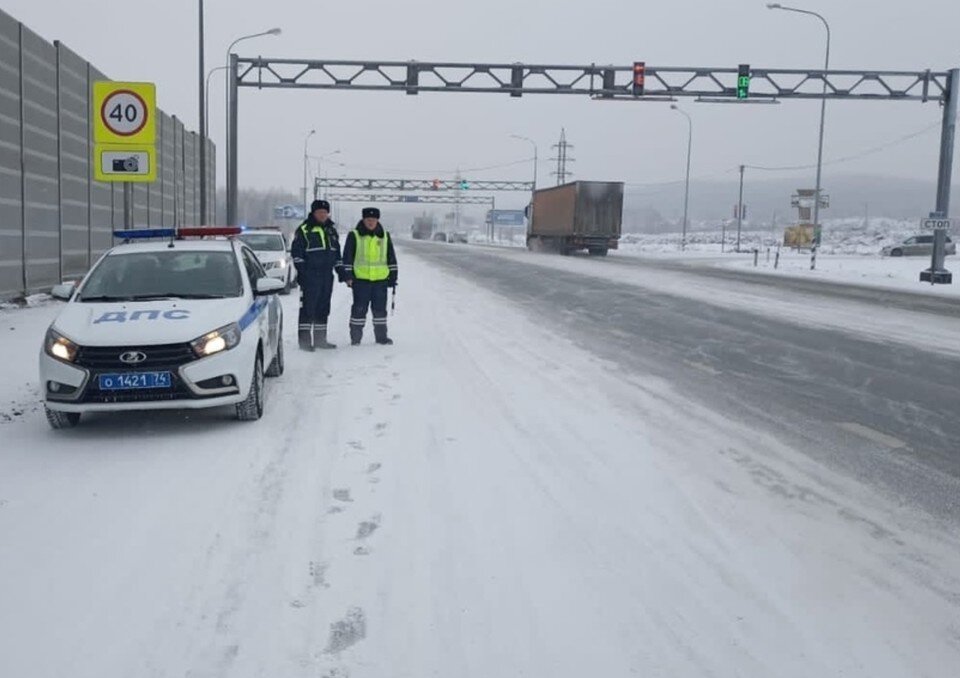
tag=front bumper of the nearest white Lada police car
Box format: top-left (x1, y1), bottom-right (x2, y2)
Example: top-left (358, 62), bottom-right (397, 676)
top-left (40, 342), bottom-right (255, 412)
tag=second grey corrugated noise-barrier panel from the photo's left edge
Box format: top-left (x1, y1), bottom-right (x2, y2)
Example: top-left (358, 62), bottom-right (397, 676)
top-left (20, 24), bottom-right (60, 292)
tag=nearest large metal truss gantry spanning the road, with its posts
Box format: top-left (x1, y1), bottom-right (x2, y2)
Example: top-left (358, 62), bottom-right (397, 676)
top-left (227, 54), bottom-right (960, 228)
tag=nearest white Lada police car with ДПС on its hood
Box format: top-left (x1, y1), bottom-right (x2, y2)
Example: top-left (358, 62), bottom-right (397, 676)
top-left (40, 228), bottom-right (284, 429)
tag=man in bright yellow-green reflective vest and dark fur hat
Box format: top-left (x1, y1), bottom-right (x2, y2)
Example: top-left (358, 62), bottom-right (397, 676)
top-left (343, 207), bottom-right (397, 346)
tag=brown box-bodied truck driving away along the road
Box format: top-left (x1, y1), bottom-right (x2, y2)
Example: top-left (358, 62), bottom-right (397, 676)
top-left (527, 181), bottom-right (623, 256)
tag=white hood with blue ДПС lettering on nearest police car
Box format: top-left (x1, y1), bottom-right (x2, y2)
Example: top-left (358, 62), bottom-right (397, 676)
top-left (53, 297), bottom-right (247, 346)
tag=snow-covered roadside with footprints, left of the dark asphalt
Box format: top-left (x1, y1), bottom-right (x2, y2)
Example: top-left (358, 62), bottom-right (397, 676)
top-left (0, 248), bottom-right (960, 678)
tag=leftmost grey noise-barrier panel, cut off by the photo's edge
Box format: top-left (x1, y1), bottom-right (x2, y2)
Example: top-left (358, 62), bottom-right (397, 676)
top-left (0, 10), bottom-right (23, 296)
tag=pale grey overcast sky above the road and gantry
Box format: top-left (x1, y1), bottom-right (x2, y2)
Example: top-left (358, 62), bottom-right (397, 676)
top-left (3, 0), bottom-right (960, 212)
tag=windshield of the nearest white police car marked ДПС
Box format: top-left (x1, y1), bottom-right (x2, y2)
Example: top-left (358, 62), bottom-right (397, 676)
top-left (78, 250), bottom-right (243, 301)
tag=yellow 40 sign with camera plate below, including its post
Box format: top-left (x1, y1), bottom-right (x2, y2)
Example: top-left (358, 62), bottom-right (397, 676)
top-left (91, 80), bottom-right (157, 229)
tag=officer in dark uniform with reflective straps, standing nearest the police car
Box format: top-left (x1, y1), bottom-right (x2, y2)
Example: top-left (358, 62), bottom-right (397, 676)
top-left (290, 200), bottom-right (342, 351)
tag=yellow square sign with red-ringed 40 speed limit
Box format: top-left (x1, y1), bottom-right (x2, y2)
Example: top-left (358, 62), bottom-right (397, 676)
top-left (92, 81), bottom-right (157, 145)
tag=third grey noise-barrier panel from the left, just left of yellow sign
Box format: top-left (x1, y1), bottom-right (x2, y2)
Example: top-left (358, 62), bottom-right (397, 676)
top-left (55, 43), bottom-right (90, 279)
